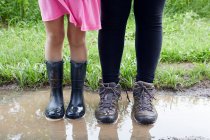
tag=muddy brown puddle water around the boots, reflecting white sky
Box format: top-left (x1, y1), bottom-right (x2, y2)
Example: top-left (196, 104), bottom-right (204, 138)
top-left (0, 89), bottom-right (210, 140)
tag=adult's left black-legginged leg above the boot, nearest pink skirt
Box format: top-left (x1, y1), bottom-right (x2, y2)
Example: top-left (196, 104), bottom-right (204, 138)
top-left (98, 0), bottom-right (131, 83)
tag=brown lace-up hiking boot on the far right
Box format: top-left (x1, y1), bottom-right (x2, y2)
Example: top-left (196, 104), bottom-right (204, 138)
top-left (132, 81), bottom-right (158, 124)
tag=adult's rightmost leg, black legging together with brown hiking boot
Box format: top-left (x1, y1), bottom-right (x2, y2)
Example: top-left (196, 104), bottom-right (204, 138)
top-left (133, 0), bottom-right (165, 124)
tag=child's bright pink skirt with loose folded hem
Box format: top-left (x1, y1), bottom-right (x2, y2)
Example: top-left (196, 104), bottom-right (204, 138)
top-left (39, 0), bottom-right (101, 31)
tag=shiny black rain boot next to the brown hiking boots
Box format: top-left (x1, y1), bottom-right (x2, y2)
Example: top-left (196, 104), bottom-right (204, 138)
top-left (66, 60), bottom-right (87, 119)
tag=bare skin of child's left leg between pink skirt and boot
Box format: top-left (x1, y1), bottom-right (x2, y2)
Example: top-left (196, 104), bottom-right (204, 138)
top-left (45, 16), bottom-right (65, 62)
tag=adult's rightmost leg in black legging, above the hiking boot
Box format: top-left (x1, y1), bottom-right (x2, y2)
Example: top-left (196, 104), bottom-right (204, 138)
top-left (134, 0), bottom-right (165, 83)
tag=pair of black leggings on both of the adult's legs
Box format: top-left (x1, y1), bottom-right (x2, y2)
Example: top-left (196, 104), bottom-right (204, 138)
top-left (98, 0), bottom-right (165, 83)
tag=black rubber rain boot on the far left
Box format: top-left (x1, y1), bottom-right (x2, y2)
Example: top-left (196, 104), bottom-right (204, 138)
top-left (45, 61), bottom-right (65, 120)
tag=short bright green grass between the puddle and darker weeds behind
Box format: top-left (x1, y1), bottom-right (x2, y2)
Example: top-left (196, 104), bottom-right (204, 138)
top-left (0, 12), bottom-right (210, 89)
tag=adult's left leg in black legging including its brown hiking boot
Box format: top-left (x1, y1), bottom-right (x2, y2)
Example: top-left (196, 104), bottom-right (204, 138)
top-left (95, 0), bottom-right (131, 123)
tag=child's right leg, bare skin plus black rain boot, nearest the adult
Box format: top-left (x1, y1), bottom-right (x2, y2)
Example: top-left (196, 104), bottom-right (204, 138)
top-left (66, 23), bottom-right (87, 119)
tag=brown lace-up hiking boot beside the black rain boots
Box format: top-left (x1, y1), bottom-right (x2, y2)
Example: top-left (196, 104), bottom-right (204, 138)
top-left (95, 82), bottom-right (121, 123)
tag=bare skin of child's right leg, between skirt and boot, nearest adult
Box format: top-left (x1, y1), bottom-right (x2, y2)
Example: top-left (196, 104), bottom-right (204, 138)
top-left (67, 23), bottom-right (87, 62)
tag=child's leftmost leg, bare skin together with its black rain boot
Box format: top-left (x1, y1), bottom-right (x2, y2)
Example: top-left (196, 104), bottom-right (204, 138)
top-left (45, 17), bottom-right (64, 120)
